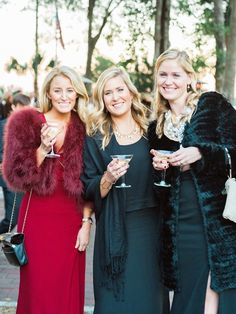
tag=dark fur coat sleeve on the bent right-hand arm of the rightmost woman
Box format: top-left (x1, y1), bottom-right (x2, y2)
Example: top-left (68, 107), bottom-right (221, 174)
top-left (183, 92), bottom-right (236, 177)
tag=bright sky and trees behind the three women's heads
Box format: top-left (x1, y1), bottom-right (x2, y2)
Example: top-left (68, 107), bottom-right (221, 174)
top-left (0, 0), bottom-right (236, 103)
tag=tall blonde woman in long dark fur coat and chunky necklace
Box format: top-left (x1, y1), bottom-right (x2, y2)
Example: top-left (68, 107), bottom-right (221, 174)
top-left (149, 49), bottom-right (236, 314)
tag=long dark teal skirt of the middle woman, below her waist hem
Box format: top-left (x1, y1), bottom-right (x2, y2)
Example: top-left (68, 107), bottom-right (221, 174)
top-left (94, 208), bottom-right (169, 314)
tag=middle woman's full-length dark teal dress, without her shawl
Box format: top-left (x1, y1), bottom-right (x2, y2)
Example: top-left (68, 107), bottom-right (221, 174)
top-left (91, 137), bottom-right (169, 314)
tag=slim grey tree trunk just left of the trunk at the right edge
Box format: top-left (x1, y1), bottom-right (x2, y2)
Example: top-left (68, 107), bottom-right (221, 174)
top-left (214, 0), bottom-right (225, 92)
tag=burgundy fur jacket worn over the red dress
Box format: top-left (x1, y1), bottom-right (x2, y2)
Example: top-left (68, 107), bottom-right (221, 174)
top-left (3, 108), bottom-right (85, 197)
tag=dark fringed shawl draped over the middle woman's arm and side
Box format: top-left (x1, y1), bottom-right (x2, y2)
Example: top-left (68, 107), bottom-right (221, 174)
top-left (81, 135), bottom-right (127, 298)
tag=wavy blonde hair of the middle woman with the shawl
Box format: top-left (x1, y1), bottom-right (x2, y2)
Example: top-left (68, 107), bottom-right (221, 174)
top-left (86, 67), bottom-right (147, 149)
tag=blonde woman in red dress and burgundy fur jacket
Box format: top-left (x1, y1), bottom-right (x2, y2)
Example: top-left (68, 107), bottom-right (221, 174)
top-left (3, 66), bottom-right (92, 314)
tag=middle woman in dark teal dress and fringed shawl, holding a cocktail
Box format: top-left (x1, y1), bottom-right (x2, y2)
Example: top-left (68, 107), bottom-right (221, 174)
top-left (82, 68), bottom-right (169, 314)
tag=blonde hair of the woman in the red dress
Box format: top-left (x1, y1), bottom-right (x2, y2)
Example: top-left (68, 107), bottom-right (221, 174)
top-left (39, 65), bottom-right (88, 122)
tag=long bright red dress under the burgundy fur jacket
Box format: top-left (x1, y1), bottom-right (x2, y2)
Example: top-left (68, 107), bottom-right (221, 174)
top-left (16, 156), bottom-right (85, 314)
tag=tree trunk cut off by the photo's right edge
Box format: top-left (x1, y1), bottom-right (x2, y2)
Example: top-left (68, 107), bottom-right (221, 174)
top-left (223, 0), bottom-right (236, 103)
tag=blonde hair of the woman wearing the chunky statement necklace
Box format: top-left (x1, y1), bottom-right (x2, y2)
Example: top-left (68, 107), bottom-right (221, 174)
top-left (153, 49), bottom-right (199, 138)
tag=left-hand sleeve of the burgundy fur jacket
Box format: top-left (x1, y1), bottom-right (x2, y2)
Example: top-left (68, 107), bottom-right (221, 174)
top-left (3, 108), bottom-right (42, 191)
